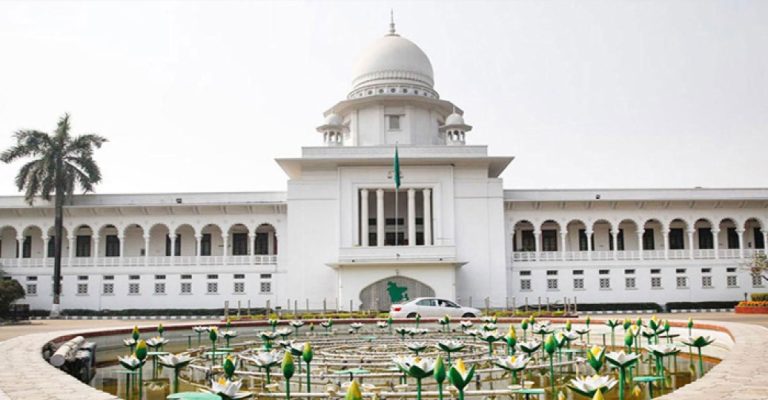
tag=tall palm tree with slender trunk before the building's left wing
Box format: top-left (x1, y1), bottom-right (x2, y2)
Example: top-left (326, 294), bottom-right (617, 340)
top-left (0, 114), bottom-right (107, 317)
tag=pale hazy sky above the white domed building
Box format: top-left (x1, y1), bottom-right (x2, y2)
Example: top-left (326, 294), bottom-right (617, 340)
top-left (0, 0), bottom-right (768, 195)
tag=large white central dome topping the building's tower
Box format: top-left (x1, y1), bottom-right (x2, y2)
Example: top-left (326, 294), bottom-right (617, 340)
top-left (352, 34), bottom-right (434, 89)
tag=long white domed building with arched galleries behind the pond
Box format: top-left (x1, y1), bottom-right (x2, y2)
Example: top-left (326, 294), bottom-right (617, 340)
top-left (0, 22), bottom-right (768, 309)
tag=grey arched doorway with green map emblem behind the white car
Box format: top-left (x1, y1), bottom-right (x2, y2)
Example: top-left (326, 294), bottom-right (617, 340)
top-left (360, 276), bottom-right (435, 311)
